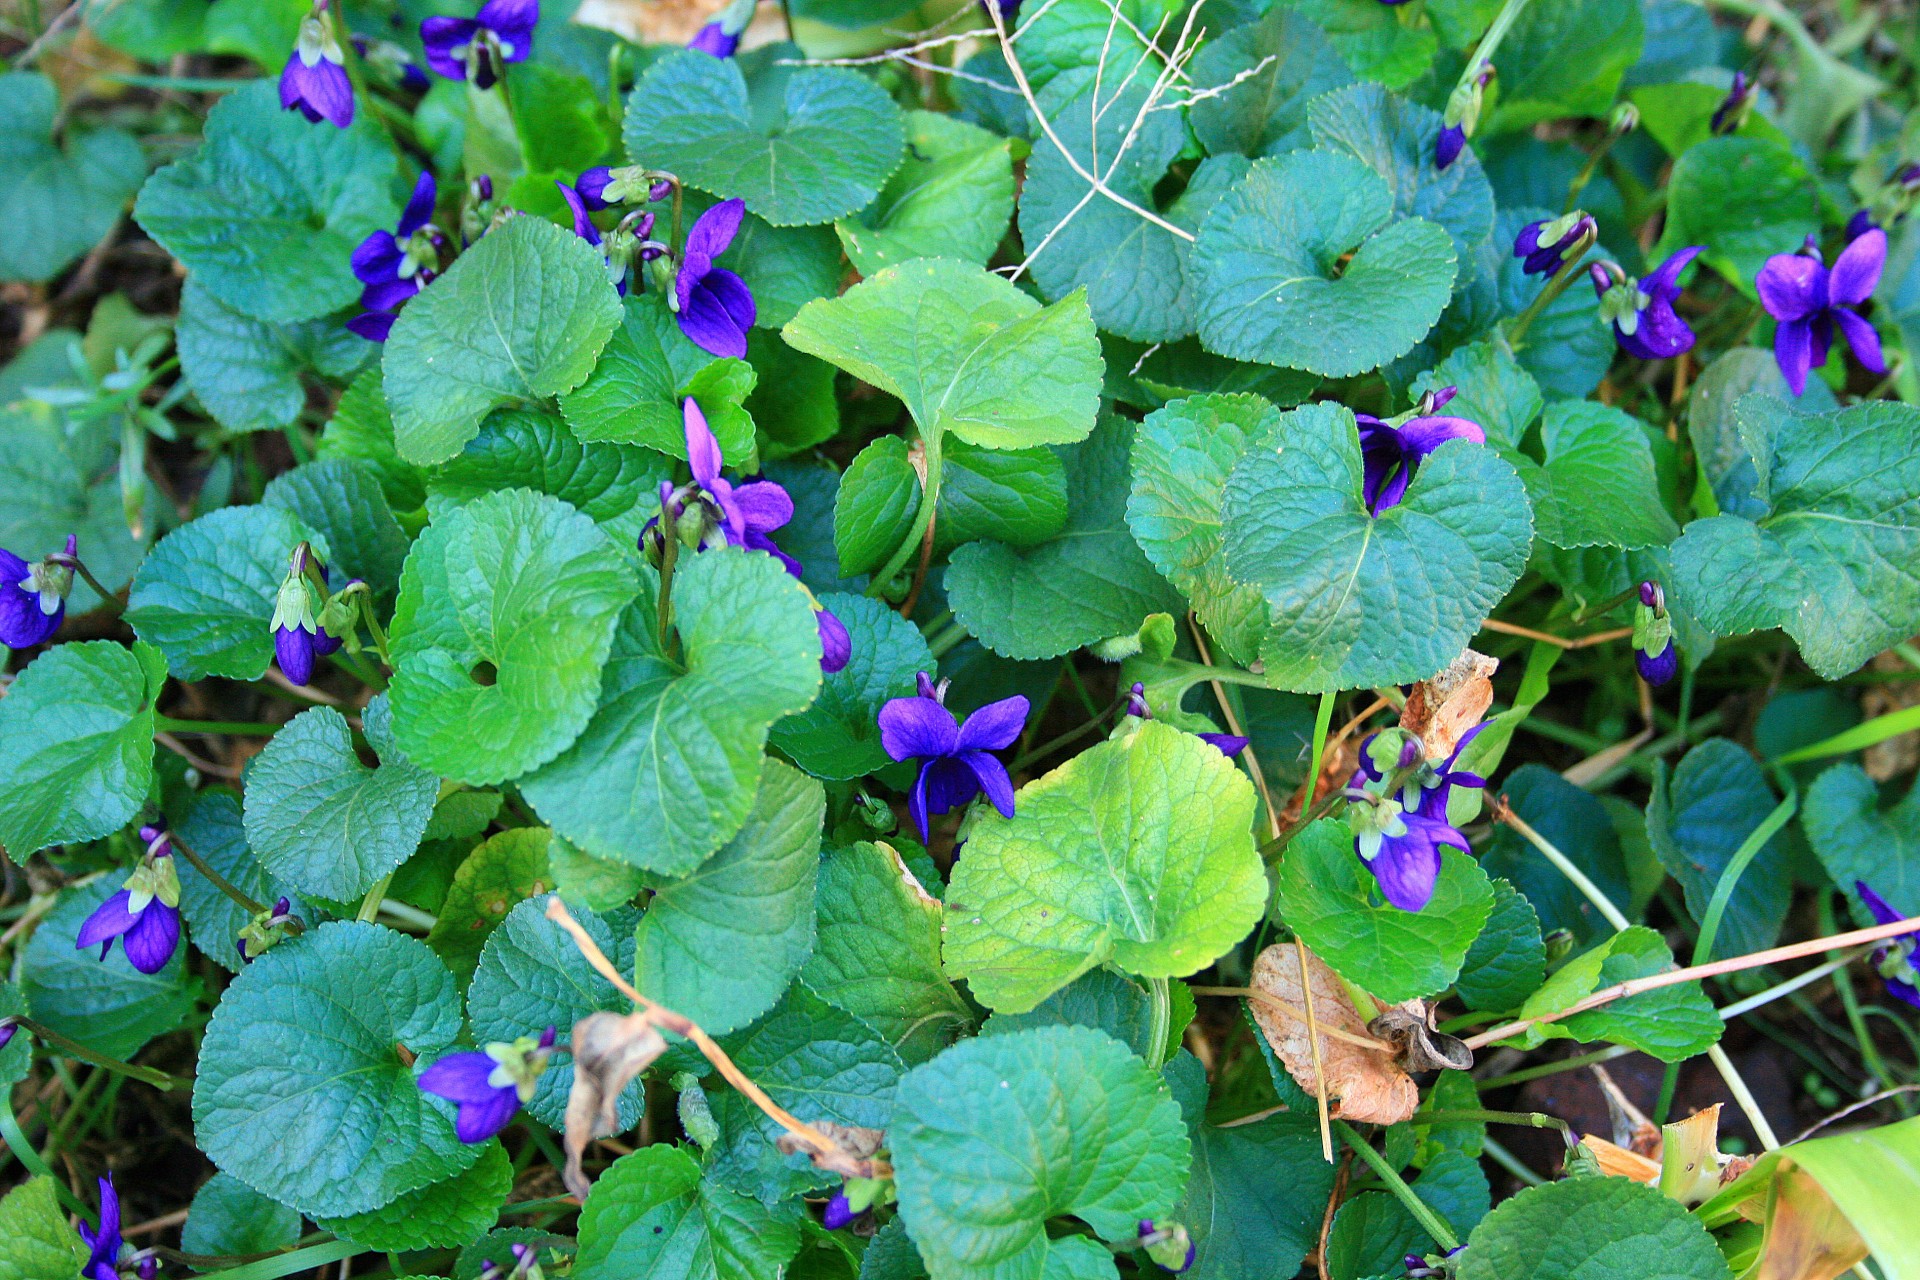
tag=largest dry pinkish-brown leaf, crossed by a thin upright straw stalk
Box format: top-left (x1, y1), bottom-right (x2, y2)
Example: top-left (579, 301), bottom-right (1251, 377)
top-left (1248, 942), bottom-right (1421, 1125)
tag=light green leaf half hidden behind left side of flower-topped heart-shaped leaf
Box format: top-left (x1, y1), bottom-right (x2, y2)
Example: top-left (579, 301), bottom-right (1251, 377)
top-left (1127, 395), bottom-right (1281, 664)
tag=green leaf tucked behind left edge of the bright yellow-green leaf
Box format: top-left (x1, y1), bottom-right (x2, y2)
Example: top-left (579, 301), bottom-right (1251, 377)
top-left (801, 841), bottom-right (973, 1063)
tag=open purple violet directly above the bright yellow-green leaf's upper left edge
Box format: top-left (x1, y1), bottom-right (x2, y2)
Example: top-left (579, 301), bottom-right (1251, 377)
top-left (879, 672), bottom-right (1027, 842)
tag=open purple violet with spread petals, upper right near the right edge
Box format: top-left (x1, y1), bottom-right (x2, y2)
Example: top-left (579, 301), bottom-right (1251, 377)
top-left (1755, 226), bottom-right (1887, 395)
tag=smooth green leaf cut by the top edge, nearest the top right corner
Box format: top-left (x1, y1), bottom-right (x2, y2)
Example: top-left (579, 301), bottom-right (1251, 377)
top-left (1484, 0), bottom-right (1645, 132)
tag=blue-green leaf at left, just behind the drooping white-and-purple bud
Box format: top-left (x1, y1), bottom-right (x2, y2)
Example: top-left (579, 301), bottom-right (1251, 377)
top-left (127, 505), bottom-right (328, 679)
